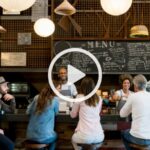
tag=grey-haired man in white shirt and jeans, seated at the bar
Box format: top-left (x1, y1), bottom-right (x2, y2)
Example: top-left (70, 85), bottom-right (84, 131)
top-left (120, 75), bottom-right (150, 150)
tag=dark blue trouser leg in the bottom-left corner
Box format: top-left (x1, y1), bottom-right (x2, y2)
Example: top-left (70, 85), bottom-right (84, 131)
top-left (0, 134), bottom-right (14, 150)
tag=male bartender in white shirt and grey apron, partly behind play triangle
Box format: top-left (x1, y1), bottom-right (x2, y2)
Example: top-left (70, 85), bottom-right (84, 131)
top-left (58, 67), bottom-right (77, 98)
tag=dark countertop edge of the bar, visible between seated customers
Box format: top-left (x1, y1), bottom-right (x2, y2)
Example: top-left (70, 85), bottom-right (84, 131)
top-left (1, 111), bottom-right (128, 130)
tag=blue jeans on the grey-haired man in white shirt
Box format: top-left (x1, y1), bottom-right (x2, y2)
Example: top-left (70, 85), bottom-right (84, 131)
top-left (121, 130), bottom-right (150, 150)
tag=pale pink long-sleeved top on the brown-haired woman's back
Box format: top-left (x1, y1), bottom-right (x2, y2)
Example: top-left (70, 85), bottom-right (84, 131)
top-left (71, 95), bottom-right (103, 135)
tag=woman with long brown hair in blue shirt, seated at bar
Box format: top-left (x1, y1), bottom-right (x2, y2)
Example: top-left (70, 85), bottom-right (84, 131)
top-left (26, 84), bottom-right (60, 150)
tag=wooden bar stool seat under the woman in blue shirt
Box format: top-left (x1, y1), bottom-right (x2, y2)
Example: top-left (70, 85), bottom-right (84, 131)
top-left (23, 140), bottom-right (49, 150)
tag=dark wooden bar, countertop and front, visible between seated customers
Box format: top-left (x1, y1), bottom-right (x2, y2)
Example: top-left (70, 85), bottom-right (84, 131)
top-left (1, 110), bottom-right (130, 150)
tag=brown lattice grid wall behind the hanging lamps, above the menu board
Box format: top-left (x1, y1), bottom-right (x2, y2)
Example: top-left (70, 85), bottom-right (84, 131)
top-left (0, 0), bottom-right (150, 72)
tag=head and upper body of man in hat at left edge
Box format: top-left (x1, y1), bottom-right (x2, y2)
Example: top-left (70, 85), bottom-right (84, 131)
top-left (0, 76), bottom-right (16, 113)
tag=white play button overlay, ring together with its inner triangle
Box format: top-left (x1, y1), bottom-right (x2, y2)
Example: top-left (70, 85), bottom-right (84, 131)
top-left (48, 48), bottom-right (102, 102)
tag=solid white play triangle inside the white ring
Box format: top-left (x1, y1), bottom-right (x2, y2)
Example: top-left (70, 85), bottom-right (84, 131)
top-left (67, 65), bottom-right (86, 84)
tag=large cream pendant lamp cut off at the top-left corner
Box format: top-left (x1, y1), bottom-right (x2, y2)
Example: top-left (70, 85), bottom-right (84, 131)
top-left (0, 0), bottom-right (36, 12)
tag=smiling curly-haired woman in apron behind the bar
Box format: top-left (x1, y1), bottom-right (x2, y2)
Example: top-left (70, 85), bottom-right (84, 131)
top-left (112, 74), bottom-right (133, 111)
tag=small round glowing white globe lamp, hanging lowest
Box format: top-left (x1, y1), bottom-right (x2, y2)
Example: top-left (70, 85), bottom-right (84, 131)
top-left (34, 18), bottom-right (55, 37)
